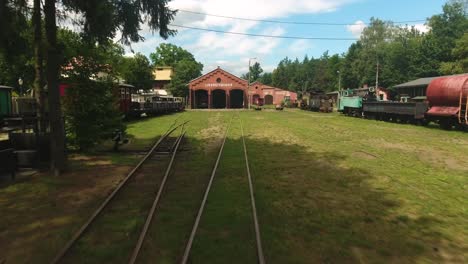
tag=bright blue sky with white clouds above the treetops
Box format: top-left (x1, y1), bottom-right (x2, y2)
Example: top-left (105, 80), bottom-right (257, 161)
top-left (128, 0), bottom-right (446, 75)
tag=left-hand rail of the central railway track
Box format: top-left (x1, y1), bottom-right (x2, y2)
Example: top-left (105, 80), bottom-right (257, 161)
top-left (181, 117), bottom-right (236, 264)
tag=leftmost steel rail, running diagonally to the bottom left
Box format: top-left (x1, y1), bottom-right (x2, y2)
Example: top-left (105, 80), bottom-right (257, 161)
top-left (51, 121), bottom-right (189, 264)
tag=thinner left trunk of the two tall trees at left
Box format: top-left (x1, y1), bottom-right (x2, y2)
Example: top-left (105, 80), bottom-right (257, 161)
top-left (32, 0), bottom-right (46, 132)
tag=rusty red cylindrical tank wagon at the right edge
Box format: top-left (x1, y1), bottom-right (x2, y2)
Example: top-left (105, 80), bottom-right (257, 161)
top-left (426, 74), bottom-right (468, 107)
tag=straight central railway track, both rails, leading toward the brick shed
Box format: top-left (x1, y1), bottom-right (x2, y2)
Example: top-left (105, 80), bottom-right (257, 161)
top-left (181, 116), bottom-right (265, 264)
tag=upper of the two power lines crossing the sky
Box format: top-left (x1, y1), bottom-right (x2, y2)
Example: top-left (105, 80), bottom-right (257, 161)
top-left (178, 9), bottom-right (426, 26)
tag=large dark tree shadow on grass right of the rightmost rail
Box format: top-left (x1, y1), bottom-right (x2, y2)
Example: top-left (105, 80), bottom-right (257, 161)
top-left (238, 139), bottom-right (467, 263)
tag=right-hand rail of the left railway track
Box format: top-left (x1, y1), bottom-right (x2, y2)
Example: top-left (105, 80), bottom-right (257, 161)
top-left (128, 126), bottom-right (187, 264)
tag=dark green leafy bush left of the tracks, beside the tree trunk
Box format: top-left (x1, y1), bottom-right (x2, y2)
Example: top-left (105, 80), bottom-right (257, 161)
top-left (64, 76), bottom-right (125, 150)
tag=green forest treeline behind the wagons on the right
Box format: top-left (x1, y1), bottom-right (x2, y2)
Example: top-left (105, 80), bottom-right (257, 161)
top-left (250, 1), bottom-right (468, 92)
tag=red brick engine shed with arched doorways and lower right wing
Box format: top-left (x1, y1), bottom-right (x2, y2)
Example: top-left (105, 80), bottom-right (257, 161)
top-left (189, 67), bottom-right (297, 109)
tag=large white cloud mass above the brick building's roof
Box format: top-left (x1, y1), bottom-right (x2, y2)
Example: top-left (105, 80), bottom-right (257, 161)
top-left (124, 0), bottom-right (356, 75)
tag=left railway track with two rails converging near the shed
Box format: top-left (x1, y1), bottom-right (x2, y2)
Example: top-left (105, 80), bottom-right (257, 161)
top-left (51, 121), bottom-right (188, 263)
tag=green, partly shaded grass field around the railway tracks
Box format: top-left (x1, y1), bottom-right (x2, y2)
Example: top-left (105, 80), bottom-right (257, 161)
top-left (0, 110), bottom-right (468, 263)
